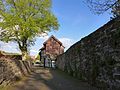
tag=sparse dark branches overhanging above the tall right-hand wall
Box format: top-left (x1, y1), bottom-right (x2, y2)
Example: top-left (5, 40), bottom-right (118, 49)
top-left (86, 0), bottom-right (120, 17)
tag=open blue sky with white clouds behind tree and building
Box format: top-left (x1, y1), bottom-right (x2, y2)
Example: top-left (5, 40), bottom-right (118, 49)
top-left (0, 0), bottom-right (111, 56)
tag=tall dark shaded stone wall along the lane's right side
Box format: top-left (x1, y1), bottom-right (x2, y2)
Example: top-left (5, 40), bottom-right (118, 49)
top-left (56, 19), bottom-right (120, 90)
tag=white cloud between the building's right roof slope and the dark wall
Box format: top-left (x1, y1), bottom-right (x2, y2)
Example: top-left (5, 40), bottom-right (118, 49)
top-left (59, 38), bottom-right (75, 50)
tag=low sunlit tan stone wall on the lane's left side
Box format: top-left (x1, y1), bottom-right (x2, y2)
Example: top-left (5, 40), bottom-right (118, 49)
top-left (0, 57), bottom-right (32, 86)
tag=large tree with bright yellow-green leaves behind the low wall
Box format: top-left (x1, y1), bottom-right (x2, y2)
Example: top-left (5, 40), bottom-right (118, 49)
top-left (0, 0), bottom-right (59, 59)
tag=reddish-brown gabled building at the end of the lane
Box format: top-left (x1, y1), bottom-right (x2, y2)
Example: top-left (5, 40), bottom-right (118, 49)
top-left (39, 35), bottom-right (65, 67)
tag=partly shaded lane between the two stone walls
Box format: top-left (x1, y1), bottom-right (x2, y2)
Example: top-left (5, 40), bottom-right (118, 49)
top-left (9, 68), bottom-right (97, 90)
